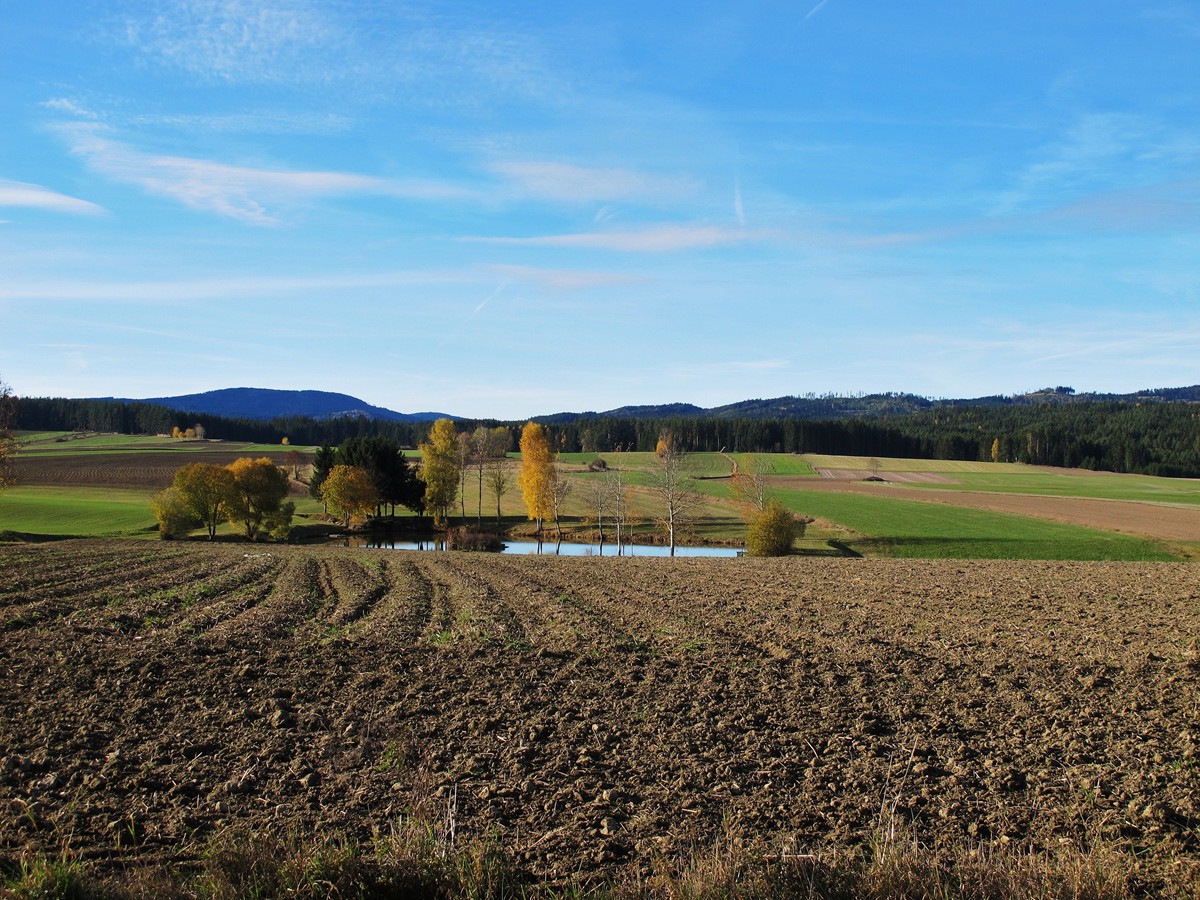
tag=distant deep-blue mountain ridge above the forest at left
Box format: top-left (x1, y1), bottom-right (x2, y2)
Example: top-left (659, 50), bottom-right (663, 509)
top-left (103, 388), bottom-right (458, 422)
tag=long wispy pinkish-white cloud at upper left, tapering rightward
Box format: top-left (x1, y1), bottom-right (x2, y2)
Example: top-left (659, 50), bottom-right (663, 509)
top-left (64, 125), bottom-right (472, 224)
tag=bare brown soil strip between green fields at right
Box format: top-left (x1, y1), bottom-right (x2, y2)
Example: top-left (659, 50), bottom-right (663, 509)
top-left (773, 480), bottom-right (1200, 541)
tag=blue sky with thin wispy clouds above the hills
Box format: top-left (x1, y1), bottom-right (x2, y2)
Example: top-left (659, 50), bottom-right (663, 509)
top-left (0, 0), bottom-right (1200, 419)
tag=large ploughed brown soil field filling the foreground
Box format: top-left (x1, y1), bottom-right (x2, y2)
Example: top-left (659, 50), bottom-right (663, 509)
top-left (0, 541), bottom-right (1200, 881)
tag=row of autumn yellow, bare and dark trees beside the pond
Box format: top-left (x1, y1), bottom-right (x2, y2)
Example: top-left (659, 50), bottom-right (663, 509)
top-left (151, 419), bottom-right (798, 556)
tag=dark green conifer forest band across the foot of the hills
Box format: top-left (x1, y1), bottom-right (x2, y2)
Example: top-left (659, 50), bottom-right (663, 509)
top-left (18, 398), bottom-right (1200, 478)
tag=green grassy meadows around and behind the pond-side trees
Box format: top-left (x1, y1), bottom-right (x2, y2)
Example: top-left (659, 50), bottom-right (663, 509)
top-left (0, 432), bottom-right (1200, 560)
